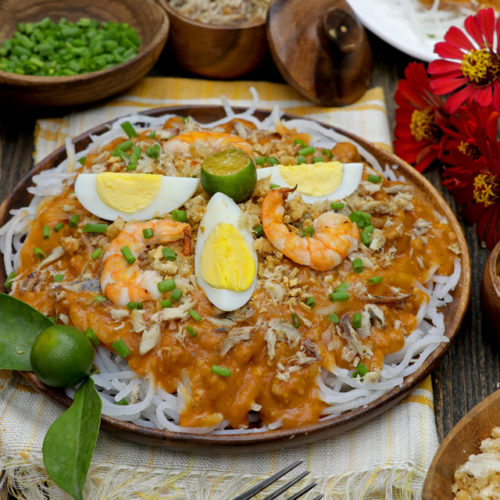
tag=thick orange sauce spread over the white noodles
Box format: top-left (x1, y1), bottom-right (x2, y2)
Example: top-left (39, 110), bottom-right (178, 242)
top-left (11, 121), bottom-right (457, 428)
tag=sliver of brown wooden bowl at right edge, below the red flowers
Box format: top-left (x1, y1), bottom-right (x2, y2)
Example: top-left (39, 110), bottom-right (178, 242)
top-left (481, 243), bottom-right (500, 342)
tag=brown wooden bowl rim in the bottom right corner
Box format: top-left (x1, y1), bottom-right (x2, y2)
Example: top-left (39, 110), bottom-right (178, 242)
top-left (422, 390), bottom-right (500, 500)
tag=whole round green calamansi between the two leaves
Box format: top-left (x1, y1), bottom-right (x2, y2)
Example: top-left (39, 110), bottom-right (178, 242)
top-left (30, 325), bottom-right (94, 387)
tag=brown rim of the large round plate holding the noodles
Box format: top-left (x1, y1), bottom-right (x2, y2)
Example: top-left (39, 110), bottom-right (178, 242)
top-left (0, 106), bottom-right (471, 451)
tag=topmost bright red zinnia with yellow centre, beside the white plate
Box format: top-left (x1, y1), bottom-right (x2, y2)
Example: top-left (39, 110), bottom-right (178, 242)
top-left (429, 8), bottom-right (500, 113)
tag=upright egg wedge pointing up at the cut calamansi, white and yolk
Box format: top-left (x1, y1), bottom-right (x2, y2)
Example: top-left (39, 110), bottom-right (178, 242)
top-left (194, 193), bottom-right (257, 311)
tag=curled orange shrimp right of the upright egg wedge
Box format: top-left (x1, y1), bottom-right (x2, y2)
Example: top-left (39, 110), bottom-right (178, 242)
top-left (262, 188), bottom-right (359, 271)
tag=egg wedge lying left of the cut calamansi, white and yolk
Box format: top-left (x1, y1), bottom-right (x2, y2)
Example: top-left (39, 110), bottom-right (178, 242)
top-left (75, 172), bottom-right (199, 221)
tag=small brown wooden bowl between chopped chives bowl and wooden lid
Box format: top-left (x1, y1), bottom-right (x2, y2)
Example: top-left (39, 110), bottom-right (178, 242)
top-left (161, 0), bottom-right (267, 79)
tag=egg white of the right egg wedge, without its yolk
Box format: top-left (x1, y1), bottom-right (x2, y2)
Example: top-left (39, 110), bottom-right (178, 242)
top-left (257, 163), bottom-right (363, 203)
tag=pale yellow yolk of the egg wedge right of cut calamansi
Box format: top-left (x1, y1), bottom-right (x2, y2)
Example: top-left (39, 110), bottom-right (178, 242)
top-left (280, 161), bottom-right (344, 196)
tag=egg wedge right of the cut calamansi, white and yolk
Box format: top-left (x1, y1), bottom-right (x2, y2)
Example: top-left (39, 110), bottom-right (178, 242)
top-left (257, 161), bottom-right (363, 203)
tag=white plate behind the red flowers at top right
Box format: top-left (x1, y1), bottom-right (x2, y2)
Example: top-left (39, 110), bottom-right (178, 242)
top-left (347, 0), bottom-right (466, 62)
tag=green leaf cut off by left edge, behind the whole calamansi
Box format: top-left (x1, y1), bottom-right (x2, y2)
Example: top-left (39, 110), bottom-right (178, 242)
top-left (0, 293), bottom-right (52, 371)
